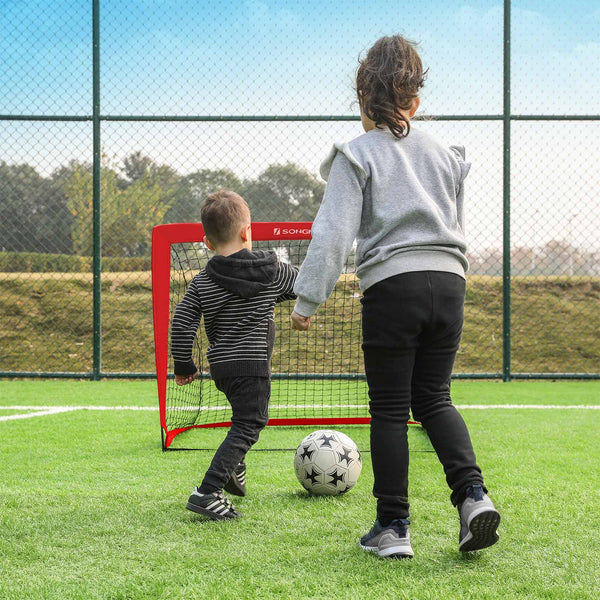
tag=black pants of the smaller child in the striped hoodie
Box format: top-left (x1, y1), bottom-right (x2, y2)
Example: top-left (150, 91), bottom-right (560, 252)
top-left (200, 377), bottom-right (271, 494)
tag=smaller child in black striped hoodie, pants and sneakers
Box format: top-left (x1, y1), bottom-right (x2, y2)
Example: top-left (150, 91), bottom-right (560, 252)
top-left (171, 190), bottom-right (298, 520)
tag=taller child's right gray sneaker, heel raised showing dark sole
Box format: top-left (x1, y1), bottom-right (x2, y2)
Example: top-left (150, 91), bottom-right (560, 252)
top-left (458, 484), bottom-right (500, 552)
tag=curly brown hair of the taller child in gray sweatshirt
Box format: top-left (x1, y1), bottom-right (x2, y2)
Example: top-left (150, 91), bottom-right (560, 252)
top-left (356, 35), bottom-right (427, 138)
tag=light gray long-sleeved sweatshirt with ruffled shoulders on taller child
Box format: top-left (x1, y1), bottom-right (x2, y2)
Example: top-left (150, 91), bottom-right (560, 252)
top-left (294, 126), bottom-right (471, 317)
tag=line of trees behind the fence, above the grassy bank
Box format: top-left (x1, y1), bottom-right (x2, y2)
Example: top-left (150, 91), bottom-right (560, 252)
top-left (0, 152), bottom-right (600, 276)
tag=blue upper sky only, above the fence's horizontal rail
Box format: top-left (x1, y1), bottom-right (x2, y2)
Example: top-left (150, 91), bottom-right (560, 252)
top-left (0, 0), bottom-right (600, 115)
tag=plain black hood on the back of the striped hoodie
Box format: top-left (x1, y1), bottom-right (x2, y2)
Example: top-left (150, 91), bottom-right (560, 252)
top-left (204, 248), bottom-right (277, 298)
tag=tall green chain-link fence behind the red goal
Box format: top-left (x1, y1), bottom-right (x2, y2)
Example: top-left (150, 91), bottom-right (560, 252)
top-left (0, 0), bottom-right (600, 379)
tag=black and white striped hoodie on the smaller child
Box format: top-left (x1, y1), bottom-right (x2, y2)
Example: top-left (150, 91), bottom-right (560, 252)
top-left (171, 249), bottom-right (298, 379)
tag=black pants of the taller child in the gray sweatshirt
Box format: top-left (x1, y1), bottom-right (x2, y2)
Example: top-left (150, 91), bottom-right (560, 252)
top-left (362, 271), bottom-right (483, 522)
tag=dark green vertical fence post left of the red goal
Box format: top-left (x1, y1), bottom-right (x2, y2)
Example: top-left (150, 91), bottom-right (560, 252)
top-left (92, 0), bottom-right (102, 380)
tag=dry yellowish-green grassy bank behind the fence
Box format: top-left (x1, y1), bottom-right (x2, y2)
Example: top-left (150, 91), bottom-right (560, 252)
top-left (0, 273), bottom-right (600, 373)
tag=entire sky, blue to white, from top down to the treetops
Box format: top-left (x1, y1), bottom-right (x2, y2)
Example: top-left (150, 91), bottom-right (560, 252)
top-left (0, 0), bottom-right (600, 246)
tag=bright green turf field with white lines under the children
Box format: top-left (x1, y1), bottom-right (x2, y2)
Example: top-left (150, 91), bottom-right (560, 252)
top-left (0, 380), bottom-right (600, 600)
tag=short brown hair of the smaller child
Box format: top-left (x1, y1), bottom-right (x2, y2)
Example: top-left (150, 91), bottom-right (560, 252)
top-left (200, 190), bottom-right (250, 245)
